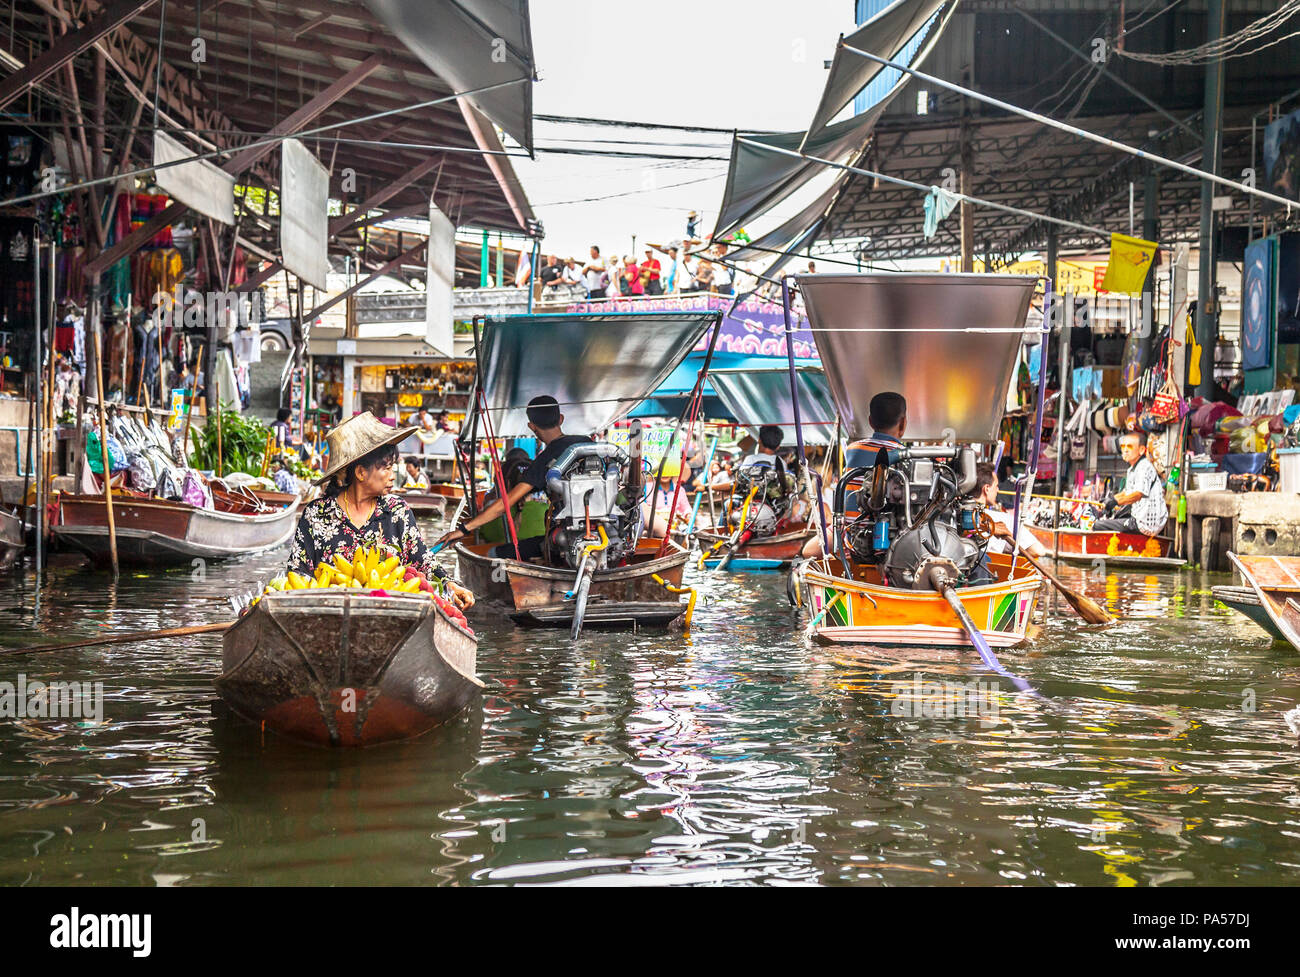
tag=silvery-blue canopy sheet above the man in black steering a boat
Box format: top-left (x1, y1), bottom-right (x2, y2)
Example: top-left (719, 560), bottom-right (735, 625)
top-left (478, 312), bottom-right (719, 438)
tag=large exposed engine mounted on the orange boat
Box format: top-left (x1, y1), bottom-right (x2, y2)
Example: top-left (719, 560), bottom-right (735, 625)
top-left (835, 446), bottom-right (987, 590)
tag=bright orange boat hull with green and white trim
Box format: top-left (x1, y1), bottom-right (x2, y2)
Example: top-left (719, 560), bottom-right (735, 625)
top-left (802, 553), bottom-right (1043, 648)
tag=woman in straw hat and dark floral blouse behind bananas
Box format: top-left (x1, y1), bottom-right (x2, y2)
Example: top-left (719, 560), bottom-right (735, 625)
top-left (289, 411), bottom-right (475, 608)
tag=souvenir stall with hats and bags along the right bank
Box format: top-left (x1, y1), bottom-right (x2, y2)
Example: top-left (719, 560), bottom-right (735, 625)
top-left (1004, 234), bottom-right (1300, 512)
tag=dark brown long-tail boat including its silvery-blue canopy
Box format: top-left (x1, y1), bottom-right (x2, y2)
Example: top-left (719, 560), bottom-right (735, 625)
top-left (455, 312), bottom-right (720, 637)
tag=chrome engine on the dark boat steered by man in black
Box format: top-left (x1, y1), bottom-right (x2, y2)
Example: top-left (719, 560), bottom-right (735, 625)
top-left (546, 443), bottom-right (641, 570)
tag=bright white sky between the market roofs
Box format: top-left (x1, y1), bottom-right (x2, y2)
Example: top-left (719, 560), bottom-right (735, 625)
top-left (512, 0), bottom-right (855, 260)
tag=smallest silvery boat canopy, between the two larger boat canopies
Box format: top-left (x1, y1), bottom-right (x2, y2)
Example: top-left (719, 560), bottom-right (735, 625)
top-left (709, 366), bottom-right (836, 444)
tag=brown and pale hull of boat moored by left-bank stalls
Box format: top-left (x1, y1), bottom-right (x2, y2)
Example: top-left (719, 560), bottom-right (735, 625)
top-left (51, 495), bottom-right (300, 566)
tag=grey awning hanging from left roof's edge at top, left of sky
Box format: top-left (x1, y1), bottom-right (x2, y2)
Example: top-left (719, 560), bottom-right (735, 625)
top-left (365, 0), bottom-right (537, 153)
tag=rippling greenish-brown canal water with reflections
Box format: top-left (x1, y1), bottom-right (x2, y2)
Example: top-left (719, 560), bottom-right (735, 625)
top-left (0, 527), bottom-right (1300, 886)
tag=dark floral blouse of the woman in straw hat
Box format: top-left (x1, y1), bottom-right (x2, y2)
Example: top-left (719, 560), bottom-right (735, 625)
top-left (289, 495), bottom-right (446, 578)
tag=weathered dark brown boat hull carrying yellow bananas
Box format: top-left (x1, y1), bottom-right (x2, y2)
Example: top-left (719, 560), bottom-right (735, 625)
top-left (216, 590), bottom-right (482, 746)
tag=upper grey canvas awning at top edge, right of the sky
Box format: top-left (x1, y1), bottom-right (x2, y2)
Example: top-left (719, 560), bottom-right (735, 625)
top-left (809, 0), bottom-right (957, 136)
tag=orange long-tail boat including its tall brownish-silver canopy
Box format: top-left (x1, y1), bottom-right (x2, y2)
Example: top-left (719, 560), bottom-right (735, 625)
top-left (783, 273), bottom-right (1043, 652)
